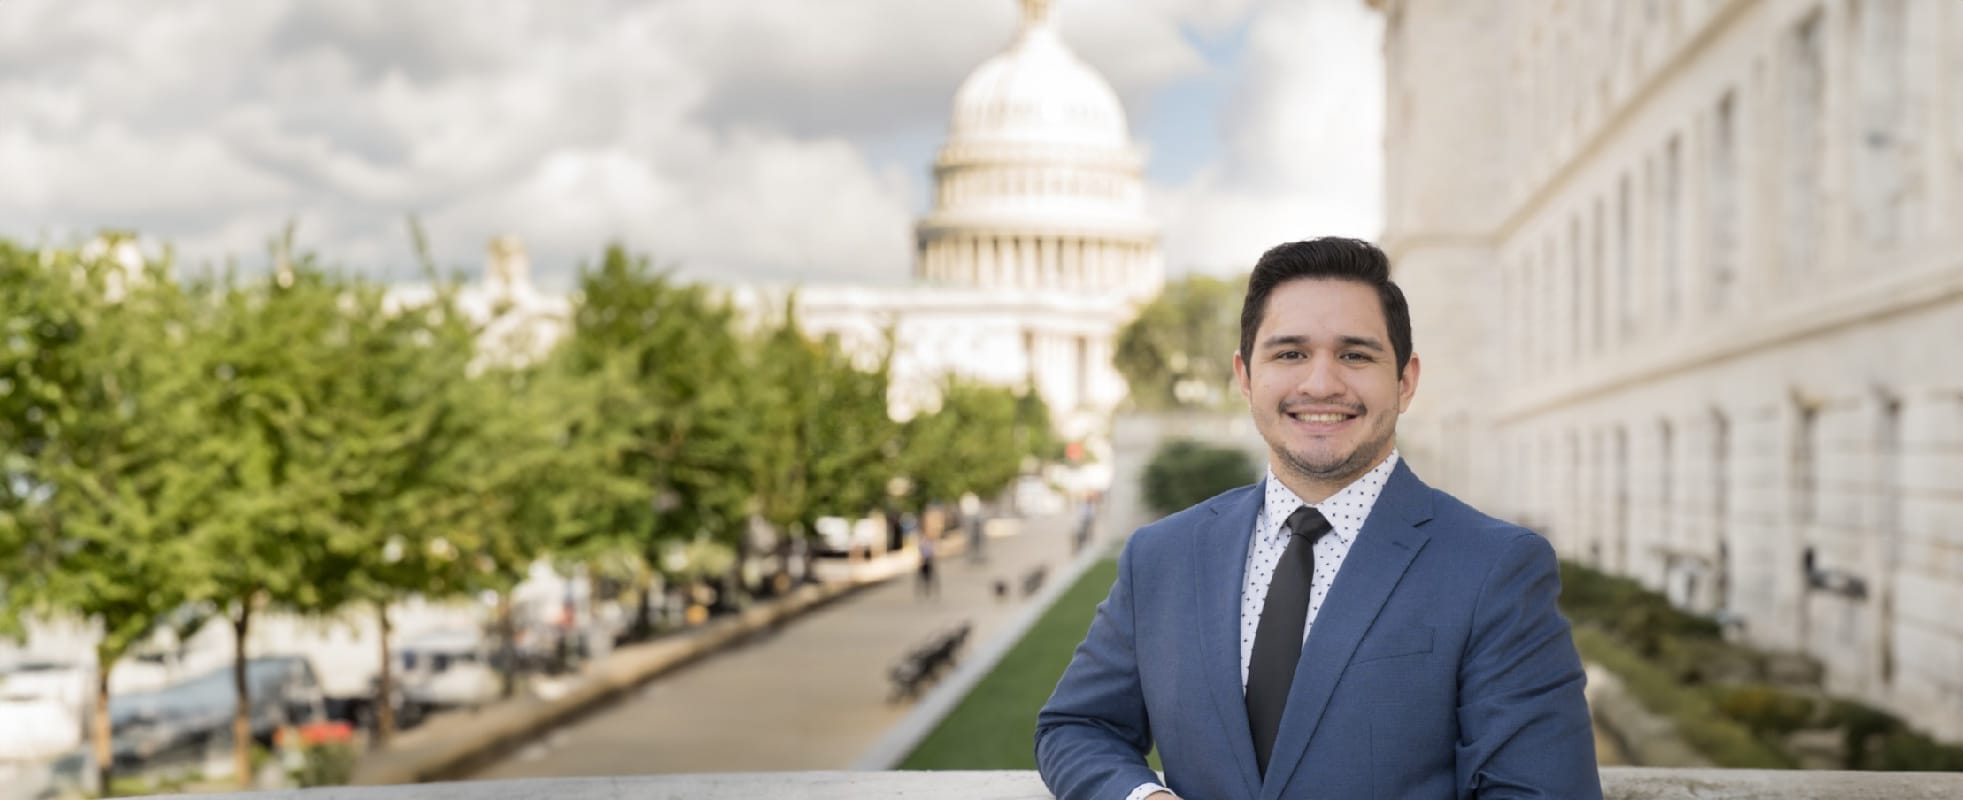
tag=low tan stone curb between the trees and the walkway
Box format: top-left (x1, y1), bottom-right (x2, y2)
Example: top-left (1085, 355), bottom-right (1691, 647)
top-left (347, 571), bottom-right (887, 784)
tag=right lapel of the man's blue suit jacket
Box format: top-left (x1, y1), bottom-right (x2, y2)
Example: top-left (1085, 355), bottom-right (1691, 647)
top-left (1264, 459), bottom-right (1431, 798)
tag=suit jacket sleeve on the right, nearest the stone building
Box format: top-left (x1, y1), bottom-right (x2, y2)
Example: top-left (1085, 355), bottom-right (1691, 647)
top-left (1459, 533), bottom-right (1602, 800)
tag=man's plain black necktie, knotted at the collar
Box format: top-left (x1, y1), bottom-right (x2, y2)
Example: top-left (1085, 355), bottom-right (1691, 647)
top-left (1247, 506), bottom-right (1329, 775)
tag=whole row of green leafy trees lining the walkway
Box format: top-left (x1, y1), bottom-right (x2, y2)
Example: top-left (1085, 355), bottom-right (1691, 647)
top-left (0, 237), bottom-right (1054, 790)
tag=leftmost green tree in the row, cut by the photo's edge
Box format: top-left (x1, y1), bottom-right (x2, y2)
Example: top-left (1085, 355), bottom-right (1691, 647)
top-left (0, 237), bottom-right (222, 792)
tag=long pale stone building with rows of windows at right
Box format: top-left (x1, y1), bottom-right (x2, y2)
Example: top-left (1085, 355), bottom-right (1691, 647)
top-left (1372, 0), bottom-right (1963, 739)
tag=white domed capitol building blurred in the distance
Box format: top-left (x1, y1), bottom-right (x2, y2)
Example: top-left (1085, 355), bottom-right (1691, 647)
top-left (463, 0), bottom-right (1164, 455)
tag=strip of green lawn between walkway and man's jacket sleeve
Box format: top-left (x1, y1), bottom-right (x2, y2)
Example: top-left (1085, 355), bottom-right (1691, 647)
top-left (899, 559), bottom-right (1117, 769)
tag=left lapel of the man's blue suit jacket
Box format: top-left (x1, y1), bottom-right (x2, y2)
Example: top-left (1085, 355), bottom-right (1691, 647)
top-left (1194, 484), bottom-right (1266, 796)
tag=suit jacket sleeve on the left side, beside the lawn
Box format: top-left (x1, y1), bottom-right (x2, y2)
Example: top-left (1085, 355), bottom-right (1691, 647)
top-left (1036, 537), bottom-right (1158, 800)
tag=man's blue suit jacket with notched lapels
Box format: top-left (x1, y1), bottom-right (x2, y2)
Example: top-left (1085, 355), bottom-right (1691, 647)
top-left (1036, 461), bottom-right (1602, 800)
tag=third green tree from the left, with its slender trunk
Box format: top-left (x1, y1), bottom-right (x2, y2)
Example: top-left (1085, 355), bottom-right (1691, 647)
top-left (312, 280), bottom-right (502, 741)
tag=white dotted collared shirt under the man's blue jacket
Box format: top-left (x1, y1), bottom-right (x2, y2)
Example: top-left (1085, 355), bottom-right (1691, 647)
top-left (1241, 451), bottom-right (1398, 690)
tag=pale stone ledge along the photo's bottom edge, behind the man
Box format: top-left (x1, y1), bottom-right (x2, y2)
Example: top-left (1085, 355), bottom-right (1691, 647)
top-left (164, 767), bottom-right (1963, 800)
